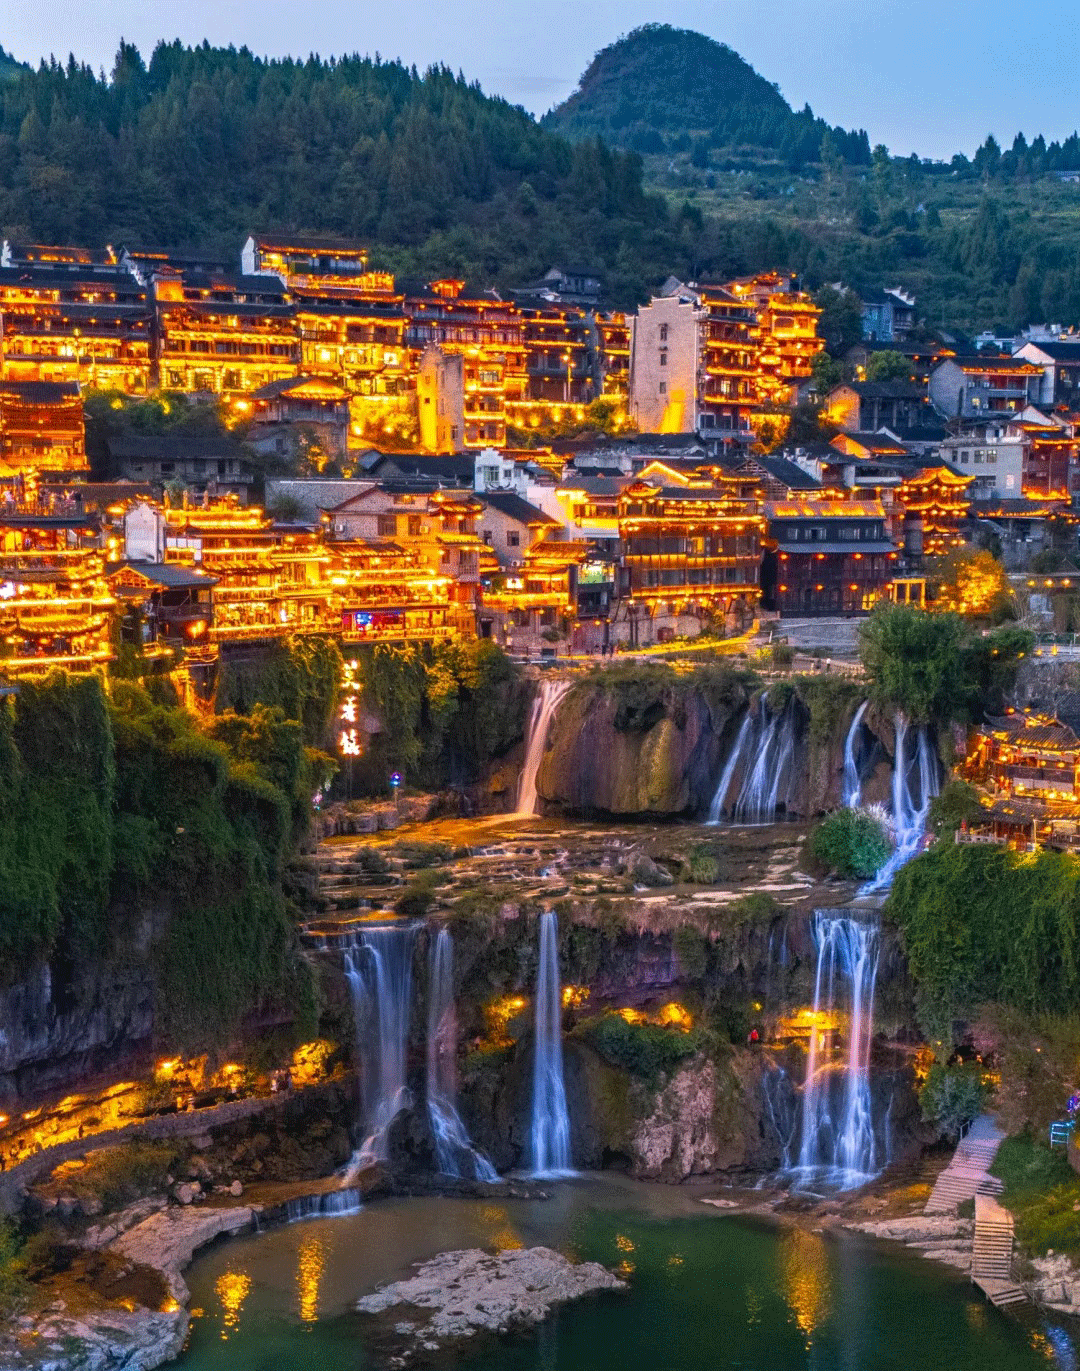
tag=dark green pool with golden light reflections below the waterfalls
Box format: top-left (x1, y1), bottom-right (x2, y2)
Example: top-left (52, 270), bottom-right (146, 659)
top-left (181, 1178), bottom-right (1080, 1371)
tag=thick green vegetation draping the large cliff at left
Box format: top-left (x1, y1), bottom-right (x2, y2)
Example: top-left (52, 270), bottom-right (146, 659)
top-left (0, 673), bottom-right (329, 1049)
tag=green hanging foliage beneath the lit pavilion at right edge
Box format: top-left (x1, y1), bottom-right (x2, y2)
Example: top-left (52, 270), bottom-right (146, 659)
top-left (887, 843), bottom-right (1080, 1056)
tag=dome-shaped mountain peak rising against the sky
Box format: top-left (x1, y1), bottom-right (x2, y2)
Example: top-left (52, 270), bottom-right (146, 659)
top-left (543, 23), bottom-right (870, 165)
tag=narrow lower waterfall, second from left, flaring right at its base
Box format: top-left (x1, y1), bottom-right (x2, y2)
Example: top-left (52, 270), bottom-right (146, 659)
top-left (428, 928), bottom-right (499, 1180)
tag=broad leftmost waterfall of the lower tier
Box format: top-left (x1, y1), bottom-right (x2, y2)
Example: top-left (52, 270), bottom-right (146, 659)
top-left (344, 924), bottom-right (417, 1169)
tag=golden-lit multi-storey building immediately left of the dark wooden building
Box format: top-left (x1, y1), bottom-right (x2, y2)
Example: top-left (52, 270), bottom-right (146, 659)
top-left (618, 477), bottom-right (763, 636)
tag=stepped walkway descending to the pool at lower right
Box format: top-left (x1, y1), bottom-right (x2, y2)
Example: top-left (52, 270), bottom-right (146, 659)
top-left (924, 1115), bottom-right (1028, 1308)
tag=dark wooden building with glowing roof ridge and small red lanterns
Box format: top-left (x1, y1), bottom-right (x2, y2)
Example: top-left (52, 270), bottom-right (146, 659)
top-left (761, 499), bottom-right (896, 614)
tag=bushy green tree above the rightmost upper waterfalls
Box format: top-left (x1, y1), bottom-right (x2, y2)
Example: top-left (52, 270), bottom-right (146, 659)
top-left (859, 605), bottom-right (1033, 724)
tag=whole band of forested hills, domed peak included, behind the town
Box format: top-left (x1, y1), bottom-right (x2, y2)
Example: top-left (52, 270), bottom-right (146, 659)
top-left (0, 26), bottom-right (1080, 333)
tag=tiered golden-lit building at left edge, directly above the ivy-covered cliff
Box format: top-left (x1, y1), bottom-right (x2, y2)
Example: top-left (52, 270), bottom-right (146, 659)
top-left (0, 489), bottom-right (115, 680)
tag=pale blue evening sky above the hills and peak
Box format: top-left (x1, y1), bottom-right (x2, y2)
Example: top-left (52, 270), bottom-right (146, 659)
top-left (8, 0), bottom-right (1080, 158)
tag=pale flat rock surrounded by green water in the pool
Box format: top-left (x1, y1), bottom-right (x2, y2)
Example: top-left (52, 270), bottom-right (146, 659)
top-left (356, 1248), bottom-right (625, 1363)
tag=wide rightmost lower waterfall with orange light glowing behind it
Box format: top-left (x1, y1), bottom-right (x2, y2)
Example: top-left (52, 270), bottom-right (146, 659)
top-left (794, 910), bottom-right (880, 1190)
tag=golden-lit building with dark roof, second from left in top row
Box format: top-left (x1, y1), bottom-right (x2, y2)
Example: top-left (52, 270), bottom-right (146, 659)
top-left (149, 262), bottom-right (300, 396)
